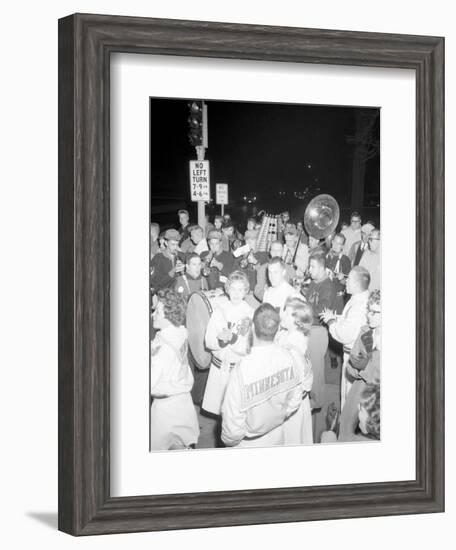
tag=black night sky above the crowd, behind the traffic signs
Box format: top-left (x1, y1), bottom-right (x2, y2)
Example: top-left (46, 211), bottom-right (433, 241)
top-left (150, 98), bottom-right (380, 227)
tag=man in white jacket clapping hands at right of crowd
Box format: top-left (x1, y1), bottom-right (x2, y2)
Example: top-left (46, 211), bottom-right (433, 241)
top-left (320, 266), bottom-right (370, 410)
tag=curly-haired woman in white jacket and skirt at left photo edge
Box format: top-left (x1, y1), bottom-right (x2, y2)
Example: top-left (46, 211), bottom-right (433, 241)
top-left (150, 289), bottom-right (199, 450)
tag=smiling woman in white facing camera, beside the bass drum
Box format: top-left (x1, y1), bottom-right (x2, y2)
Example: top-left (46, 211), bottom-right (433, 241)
top-left (202, 271), bottom-right (253, 415)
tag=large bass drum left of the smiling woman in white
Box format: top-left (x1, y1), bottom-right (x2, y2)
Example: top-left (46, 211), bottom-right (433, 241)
top-left (186, 290), bottom-right (228, 370)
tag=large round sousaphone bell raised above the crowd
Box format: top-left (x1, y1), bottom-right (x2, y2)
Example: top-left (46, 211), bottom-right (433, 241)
top-left (304, 194), bottom-right (340, 240)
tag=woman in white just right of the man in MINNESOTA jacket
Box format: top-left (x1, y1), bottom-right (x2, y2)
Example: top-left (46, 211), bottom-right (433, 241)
top-left (275, 298), bottom-right (313, 445)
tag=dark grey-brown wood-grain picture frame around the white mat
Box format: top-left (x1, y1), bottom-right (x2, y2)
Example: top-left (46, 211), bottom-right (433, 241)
top-left (58, 14), bottom-right (444, 535)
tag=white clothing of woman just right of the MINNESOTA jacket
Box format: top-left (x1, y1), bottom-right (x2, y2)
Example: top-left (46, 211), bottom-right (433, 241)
top-left (275, 330), bottom-right (313, 445)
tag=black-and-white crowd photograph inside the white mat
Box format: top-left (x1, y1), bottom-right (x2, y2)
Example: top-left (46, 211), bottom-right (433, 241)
top-left (149, 98), bottom-right (382, 452)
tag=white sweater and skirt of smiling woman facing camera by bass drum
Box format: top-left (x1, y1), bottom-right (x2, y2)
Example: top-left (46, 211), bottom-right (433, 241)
top-left (202, 299), bottom-right (253, 415)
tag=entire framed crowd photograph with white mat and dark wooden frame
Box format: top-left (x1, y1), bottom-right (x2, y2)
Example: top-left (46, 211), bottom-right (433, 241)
top-left (59, 14), bottom-right (444, 535)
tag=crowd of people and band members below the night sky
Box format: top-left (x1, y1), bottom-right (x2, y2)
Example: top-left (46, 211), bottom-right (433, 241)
top-left (150, 210), bottom-right (381, 450)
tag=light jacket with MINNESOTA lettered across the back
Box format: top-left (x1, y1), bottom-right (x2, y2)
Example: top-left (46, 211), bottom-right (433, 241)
top-left (222, 343), bottom-right (303, 447)
